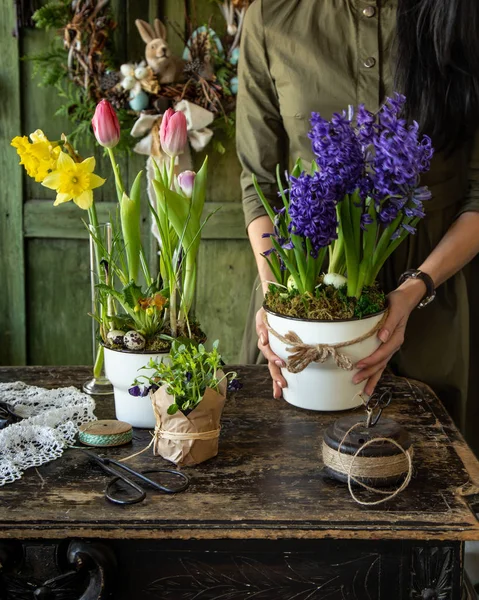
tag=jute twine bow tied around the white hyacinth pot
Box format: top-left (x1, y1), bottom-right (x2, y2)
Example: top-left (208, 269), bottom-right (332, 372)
top-left (263, 311), bottom-right (388, 373)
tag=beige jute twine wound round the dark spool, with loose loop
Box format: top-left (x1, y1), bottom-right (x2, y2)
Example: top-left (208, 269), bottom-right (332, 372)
top-left (323, 422), bottom-right (414, 506)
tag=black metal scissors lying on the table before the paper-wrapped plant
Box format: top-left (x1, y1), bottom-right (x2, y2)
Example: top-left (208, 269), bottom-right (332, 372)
top-left (77, 446), bottom-right (190, 506)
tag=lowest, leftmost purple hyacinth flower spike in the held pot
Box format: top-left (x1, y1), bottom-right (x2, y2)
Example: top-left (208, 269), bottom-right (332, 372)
top-left (289, 172), bottom-right (338, 257)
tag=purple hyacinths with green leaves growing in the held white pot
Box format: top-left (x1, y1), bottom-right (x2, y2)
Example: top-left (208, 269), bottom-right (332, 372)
top-left (253, 94), bottom-right (433, 298)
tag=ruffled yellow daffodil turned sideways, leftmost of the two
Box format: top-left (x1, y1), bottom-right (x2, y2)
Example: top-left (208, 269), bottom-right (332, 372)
top-left (11, 129), bottom-right (61, 182)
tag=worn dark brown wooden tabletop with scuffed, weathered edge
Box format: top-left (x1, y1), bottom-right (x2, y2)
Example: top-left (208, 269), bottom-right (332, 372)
top-left (0, 367), bottom-right (479, 540)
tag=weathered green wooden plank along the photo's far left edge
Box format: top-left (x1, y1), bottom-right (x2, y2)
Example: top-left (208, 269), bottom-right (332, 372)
top-left (0, 2), bottom-right (26, 365)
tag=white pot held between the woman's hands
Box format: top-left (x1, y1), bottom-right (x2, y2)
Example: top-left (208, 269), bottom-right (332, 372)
top-left (266, 309), bottom-right (384, 411)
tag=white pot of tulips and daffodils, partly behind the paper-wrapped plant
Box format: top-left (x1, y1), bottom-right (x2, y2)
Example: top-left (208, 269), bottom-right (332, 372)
top-left (105, 347), bottom-right (169, 429)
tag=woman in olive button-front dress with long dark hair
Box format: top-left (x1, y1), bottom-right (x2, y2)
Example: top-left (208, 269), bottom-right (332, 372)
top-left (237, 0), bottom-right (479, 436)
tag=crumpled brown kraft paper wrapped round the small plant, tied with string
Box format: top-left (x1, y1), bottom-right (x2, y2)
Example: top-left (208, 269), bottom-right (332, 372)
top-left (151, 372), bottom-right (227, 467)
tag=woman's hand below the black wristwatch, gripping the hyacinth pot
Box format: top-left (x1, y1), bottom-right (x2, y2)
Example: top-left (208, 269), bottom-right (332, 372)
top-left (353, 279), bottom-right (426, 396)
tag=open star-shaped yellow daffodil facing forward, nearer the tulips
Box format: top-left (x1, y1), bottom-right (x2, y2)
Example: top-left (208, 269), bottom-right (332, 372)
top-left (42, 152), bottom-right (105, 210)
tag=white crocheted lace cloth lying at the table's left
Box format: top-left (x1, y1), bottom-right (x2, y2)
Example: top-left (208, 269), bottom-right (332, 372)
top-left (0, 381), bottom-right (96, 486)
